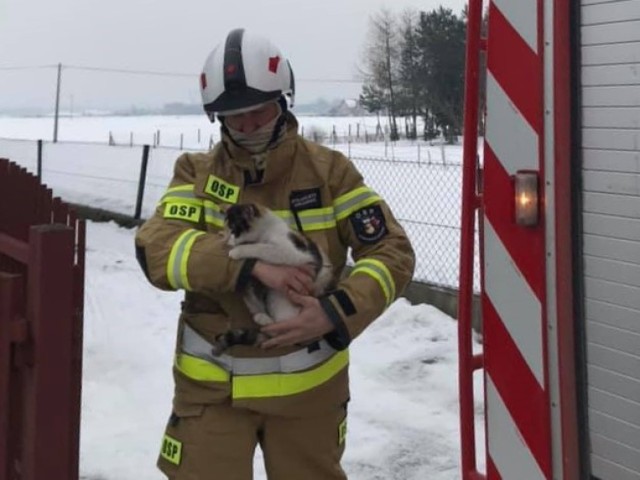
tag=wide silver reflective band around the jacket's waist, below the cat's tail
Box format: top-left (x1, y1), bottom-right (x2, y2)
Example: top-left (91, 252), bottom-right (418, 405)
top-left (182, 323), bottom-right (336, 375)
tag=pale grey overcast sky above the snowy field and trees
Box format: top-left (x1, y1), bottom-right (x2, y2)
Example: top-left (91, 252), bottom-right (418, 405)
top-left (0, 0), bottom-right (466, 109)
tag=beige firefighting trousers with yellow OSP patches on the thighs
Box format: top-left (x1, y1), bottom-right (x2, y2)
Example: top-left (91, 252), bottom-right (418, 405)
top-left (158, 404), bottom-right (347, 480)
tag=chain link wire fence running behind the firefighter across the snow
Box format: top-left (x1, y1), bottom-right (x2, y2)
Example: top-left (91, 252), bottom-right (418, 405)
top-left (0, 135), bottom-right (479, 291)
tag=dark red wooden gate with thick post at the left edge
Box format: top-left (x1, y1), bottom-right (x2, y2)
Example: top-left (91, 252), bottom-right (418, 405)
top-left (0, 159), bottom-right (85, 480)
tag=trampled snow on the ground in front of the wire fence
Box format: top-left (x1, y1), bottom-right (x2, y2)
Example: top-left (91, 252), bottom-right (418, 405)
top-left (81, 223), bottom-right (484, 480)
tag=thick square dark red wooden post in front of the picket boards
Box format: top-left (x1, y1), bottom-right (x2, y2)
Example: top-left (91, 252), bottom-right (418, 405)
top-left (22, 224), bottom-right (75, 480)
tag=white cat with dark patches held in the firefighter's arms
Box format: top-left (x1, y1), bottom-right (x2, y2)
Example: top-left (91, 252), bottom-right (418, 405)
top-left (213, 203), bottom-right (332, 355)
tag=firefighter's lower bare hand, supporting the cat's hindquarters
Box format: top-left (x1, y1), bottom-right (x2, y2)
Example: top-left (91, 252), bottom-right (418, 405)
top-left (261, 291), bottom-right (334, 348)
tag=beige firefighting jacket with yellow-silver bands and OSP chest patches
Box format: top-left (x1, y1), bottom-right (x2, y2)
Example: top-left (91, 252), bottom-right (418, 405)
top-left (136, 113), bottom-right (415, 415)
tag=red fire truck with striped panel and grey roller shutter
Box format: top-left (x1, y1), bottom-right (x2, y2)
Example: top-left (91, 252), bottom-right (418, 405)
top-left (459, 0), bottom-right (640, 480)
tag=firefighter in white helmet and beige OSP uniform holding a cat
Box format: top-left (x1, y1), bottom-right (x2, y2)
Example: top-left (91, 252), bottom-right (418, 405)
top-left (136, 29), bottom-right (415, 480)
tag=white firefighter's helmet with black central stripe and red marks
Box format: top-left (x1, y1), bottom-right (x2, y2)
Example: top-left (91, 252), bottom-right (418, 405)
top-left (200, 28), bottom-right (295, 122)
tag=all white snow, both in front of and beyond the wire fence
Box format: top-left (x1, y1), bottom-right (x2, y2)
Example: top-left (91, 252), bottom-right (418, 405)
top-left (0, 117), bottom-right (484, 480)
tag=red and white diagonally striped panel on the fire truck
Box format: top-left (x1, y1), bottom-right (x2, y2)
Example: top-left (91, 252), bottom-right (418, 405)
top-left (482, 0), bottom-right (552, 480)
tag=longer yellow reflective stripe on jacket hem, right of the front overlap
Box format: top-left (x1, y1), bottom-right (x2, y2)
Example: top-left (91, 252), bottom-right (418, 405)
top-left (232, 350), bottom-right (349, 400)
